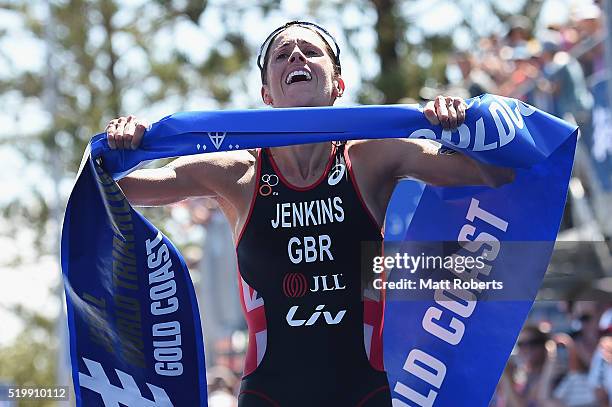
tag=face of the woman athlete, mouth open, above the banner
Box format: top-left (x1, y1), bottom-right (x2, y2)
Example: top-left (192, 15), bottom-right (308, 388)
top-left (261, 26), bottom-right (344, 107)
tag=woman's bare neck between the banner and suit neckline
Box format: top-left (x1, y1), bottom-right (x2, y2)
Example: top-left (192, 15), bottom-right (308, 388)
top-left (270, 142), bottom-right (332, 184)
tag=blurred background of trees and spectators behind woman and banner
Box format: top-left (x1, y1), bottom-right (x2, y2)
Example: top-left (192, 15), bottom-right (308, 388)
top-left (0, 0), bottom-right (612, 407)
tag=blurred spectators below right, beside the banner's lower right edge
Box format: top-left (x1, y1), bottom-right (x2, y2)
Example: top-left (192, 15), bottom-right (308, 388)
top-left (490, 301), bottom-right (612, 407)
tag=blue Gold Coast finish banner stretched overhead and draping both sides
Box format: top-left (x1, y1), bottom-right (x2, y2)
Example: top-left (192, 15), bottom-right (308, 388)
top-left (62, 95), bottom-right (576, 407)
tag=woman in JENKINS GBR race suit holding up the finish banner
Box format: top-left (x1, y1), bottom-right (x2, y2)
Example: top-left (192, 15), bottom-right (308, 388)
top-left (107, 21), bottom-right (513, 407)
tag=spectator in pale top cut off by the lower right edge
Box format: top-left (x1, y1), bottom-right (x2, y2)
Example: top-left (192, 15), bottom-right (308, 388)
top-left (589, 308), bottom-right (612, 407)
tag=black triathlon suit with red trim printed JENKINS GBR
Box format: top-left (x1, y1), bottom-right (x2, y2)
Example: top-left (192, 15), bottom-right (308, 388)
top-left (236, 145), bottom-right (391, 407)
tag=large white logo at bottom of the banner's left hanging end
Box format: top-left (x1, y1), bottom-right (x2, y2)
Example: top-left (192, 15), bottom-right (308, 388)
top-left (79, 358), bottom-right (173, 407)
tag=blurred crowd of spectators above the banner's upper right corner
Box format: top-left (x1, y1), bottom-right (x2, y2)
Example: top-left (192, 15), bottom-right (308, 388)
top-left (449, 0), bottom-right (605, 124)
